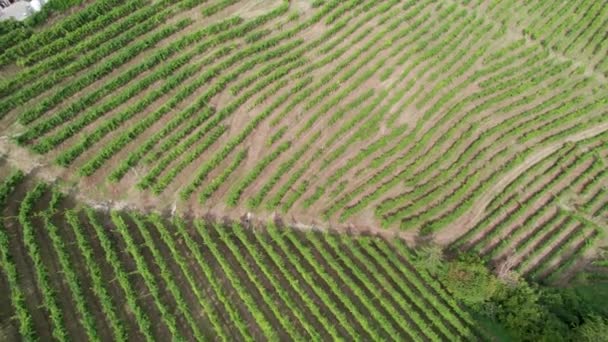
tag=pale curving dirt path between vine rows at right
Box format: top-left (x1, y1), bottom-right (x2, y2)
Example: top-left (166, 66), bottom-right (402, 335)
top-left (436, 123), bottom-right (608, 245)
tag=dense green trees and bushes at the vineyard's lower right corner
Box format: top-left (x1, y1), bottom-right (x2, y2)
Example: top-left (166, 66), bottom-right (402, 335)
top-left (434, 252), bottom-right (608, 341)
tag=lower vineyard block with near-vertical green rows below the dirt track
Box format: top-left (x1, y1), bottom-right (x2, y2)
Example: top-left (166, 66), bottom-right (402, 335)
top-left (0, 172), bottom-right (492, 341)
